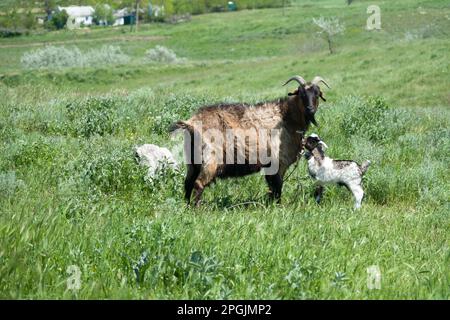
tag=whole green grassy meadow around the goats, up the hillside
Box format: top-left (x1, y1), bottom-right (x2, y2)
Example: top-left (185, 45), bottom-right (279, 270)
top-left (0, 0), bottom-right (450, 299)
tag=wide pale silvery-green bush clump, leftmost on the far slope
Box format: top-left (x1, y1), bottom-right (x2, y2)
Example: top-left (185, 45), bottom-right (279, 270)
top-left (20, 45), bottom-right (130, 69)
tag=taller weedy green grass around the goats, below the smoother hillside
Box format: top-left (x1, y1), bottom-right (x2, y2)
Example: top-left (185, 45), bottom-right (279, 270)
top-left (0, 89), bottom-right (450, 299)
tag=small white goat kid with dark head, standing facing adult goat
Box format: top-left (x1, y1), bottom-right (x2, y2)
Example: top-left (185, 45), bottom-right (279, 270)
top-left (303, 134), bottom-right (370, 209)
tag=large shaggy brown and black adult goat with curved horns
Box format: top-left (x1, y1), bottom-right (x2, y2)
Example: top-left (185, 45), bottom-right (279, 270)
top-left (172, 76), bottom-right (329, 206)
